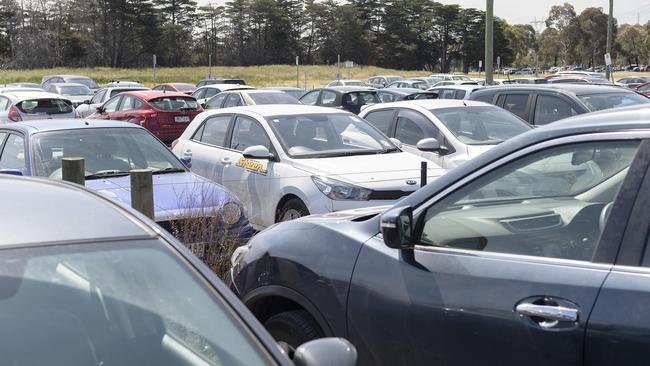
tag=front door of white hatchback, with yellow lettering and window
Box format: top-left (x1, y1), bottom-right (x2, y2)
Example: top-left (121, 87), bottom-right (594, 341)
top-left (221, 115), bottom-right (277, 227)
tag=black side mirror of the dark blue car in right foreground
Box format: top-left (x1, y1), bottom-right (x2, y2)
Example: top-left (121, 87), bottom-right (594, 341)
top-left (380, 206), bottom-right (413, 249)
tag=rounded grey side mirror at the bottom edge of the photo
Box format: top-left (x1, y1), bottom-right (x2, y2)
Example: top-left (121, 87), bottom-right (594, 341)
top-left (293, 338), bottom-right (357, 366)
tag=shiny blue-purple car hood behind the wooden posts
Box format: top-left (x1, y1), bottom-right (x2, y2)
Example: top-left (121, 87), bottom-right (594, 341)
top-left (86, 172), bottom-right (238, 221)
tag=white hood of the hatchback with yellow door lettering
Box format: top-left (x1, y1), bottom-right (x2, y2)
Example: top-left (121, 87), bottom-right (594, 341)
top-left (293, 152), bottom-right (446, 189)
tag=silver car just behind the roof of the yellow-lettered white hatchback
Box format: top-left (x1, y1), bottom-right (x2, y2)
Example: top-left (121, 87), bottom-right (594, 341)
top-left (205, 89), bottom-right (301, 109)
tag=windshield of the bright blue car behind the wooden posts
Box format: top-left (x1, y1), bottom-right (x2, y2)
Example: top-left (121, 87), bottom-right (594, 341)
top-left (32, 127), bottom-right (185, 179)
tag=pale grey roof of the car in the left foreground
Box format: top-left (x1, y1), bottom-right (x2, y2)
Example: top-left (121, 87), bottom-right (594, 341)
top-left (0, 175), bottom-right (157, 248)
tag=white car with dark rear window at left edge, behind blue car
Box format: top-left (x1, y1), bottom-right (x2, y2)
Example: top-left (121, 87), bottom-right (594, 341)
top-left (0, 90), bottom-right (77, 124)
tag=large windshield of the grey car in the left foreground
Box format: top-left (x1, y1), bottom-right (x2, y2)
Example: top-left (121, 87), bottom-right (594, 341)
top-left (0, 240), bottom-right (272, 366)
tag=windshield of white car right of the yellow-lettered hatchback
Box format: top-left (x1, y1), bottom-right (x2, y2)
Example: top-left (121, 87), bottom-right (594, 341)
top-left (431, 106), bottom-right (531, 145)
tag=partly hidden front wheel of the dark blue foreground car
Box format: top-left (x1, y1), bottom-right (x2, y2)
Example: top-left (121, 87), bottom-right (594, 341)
top-left (264, 310), bottom-right (325, 352)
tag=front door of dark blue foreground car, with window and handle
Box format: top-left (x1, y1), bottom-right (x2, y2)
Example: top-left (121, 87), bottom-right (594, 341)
top-left (348, 133), bottom-right (650, 366)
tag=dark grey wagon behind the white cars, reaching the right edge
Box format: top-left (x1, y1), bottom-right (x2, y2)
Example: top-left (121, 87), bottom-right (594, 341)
top-left (469, 84), bottom-right (650, 126)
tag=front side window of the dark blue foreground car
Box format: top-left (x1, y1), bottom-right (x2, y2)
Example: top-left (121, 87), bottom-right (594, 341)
top-left (419, 140), bottom-right (639, 261)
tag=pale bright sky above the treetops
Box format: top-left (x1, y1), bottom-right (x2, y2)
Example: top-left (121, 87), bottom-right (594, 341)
top-left (198, 0), bottom-right (650, 26)
